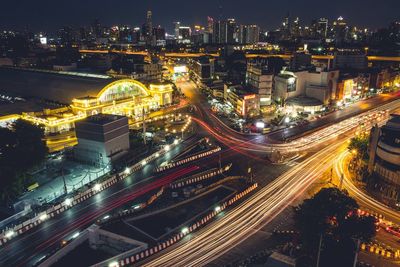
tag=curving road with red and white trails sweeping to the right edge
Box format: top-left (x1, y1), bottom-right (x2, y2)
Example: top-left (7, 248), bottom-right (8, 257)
top-left (178, 79), bottom-right (400, 153)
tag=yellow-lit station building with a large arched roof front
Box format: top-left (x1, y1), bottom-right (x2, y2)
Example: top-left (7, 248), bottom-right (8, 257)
top-left (12, 79), bottom-right (173, 133)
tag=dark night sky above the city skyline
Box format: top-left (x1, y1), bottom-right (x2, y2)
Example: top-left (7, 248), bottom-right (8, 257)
top-left (0, 0), bottom-right (400, 32)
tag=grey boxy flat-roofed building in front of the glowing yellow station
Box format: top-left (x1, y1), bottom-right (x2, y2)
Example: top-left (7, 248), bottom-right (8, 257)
top-left (74, 114), bottom-right (129, 166)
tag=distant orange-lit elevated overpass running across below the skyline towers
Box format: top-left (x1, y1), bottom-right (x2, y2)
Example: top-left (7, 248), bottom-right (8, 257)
top-left (79, 49), bottom-right (400, 62)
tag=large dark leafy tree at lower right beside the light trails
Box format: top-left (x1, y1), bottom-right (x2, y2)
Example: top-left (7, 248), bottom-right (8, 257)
top-left (295, 188), bottom-right (375, 266)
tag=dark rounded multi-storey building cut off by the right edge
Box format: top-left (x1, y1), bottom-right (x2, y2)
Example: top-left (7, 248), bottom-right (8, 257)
top-left (368, 115), bottom-right (400, 206)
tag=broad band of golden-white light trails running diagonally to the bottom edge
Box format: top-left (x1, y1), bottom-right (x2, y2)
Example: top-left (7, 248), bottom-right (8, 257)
top-left (143, 143), bottom-right (343, 266)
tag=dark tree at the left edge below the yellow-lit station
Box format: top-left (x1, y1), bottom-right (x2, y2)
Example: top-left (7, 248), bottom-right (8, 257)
top-left (0, 120), bottom-right (47, 202)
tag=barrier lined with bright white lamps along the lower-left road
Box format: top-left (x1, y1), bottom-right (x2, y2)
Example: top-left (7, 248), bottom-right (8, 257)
top-left (0, 140), bottom-right (179, 246)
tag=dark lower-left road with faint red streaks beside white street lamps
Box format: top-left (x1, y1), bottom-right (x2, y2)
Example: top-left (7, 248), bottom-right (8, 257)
top-left (0, 139), bottom-right (205, 266)
